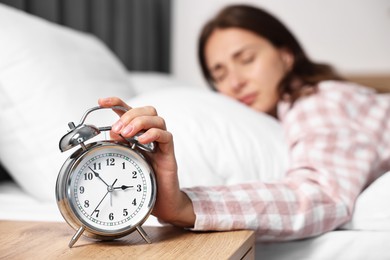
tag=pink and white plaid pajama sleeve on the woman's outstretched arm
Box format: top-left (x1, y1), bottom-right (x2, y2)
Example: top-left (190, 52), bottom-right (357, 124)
top-left (184, 82), bottom-right (390, 241)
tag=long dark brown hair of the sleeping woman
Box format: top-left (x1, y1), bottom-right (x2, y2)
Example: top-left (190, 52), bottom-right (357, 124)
top-left (198, 5), bottom-right (342, 101)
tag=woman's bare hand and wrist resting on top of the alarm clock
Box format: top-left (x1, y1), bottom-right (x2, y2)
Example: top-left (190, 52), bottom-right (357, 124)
top-left (99, 97), bottom-right (195, 227)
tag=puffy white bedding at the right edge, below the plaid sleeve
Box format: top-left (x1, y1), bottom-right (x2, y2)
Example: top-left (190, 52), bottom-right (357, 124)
top-left (342, 172), bottom-right (390, 231)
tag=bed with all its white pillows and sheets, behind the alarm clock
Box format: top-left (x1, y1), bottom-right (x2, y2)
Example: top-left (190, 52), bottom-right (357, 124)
top-left (0, 5), bottom-right (390, 259)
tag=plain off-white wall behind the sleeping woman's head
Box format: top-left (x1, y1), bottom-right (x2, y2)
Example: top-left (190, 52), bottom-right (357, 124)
top-left (171, 0), bottom-right (390, 86)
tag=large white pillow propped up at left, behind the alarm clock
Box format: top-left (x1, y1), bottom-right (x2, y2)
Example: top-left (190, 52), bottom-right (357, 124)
top-left (0, 4), bottom-right (133, 200)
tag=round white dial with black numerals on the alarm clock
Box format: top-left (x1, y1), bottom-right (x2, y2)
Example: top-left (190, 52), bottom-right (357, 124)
top-left (67, 145), bottom-right (155, 234)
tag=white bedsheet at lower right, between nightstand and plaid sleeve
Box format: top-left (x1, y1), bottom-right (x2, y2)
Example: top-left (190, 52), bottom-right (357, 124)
top-left (256, 230), bottom-right (390, 260)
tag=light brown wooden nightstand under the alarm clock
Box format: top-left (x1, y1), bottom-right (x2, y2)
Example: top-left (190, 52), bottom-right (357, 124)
top-left (0, 221), bottom-right (255, 260)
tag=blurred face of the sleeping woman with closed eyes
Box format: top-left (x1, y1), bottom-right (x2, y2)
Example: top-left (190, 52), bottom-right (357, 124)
top-left (204, 28), bottom-right (293, 116)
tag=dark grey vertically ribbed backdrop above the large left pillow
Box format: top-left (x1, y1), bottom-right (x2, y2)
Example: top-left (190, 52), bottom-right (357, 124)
top-left (0, 0), bottom-right (171, 73)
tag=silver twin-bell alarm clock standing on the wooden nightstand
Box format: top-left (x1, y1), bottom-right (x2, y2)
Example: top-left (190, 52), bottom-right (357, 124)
top-left (56, 106), bottom-right (157, 247)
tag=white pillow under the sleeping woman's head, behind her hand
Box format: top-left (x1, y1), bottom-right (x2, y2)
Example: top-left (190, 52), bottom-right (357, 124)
top-left (128, 87), bottom-right (288, 187)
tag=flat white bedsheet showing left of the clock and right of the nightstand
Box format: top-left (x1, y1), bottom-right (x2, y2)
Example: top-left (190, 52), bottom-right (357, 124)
top-left (0, 182), bottom-right (390, 260)
